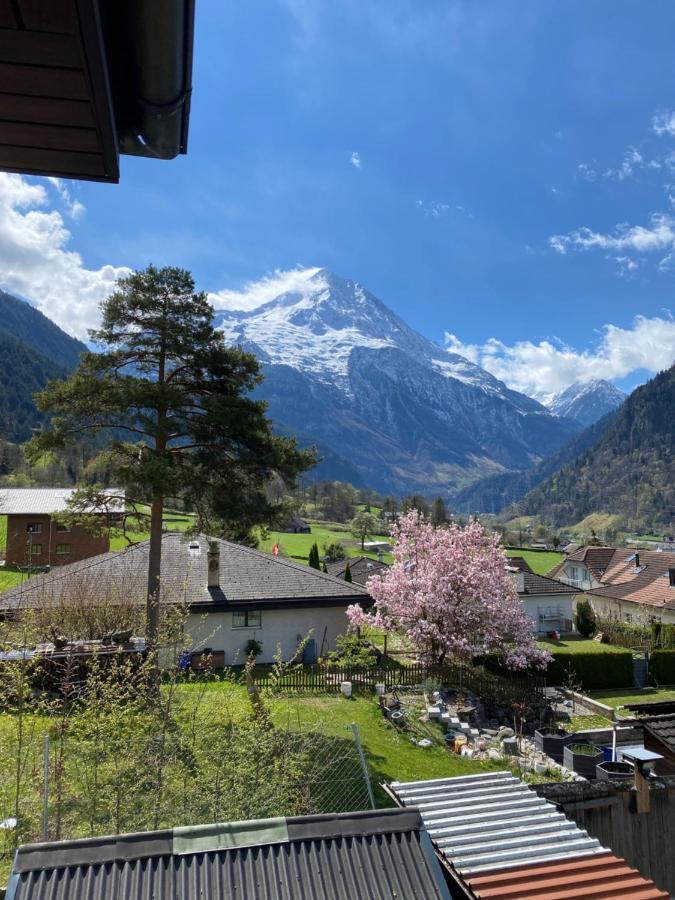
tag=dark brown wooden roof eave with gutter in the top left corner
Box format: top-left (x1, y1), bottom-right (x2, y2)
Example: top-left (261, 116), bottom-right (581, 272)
top-left (0, 0), bottom-right (194, 182)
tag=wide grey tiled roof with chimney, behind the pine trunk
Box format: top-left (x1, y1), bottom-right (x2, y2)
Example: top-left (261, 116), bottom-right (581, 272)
top-left (0, 533), bottom-right (370, 610)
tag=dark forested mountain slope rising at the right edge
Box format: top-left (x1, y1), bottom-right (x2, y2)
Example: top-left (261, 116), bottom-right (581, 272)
top-left (518, 366), bottom-right (675, 531)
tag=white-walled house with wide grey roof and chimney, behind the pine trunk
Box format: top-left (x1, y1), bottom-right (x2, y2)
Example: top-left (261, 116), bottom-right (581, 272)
top-left (0, 532), bottom-right (372, 665)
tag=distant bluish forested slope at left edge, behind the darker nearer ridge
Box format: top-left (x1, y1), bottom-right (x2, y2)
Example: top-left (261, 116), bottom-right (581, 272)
top-left (0, 291), bottom-right (87, 371)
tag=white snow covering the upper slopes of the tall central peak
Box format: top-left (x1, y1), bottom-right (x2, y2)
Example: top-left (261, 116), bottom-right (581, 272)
top-left (211, 269), bottom-right (533, 402)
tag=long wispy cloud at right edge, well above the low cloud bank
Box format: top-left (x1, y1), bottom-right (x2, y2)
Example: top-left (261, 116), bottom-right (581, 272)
top-left (549, 213), bottom-right (675, 267)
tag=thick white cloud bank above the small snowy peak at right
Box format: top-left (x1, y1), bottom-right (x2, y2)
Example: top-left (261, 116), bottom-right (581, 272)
top-left (445, 316), bottom-right (675, 401)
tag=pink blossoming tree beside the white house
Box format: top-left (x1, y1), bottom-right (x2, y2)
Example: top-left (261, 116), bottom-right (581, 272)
top-left (347, 510), bottom-right (550, 669)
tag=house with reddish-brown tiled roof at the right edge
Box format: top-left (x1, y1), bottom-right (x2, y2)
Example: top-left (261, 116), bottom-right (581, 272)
top-left (548, 547), bottom-right (675, 624)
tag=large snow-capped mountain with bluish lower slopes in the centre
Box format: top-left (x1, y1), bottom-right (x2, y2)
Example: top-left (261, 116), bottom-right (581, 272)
top-left (212, 269), bottom-right (575, 496)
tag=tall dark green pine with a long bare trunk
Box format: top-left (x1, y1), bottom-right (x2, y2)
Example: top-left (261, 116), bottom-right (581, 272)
top-left (28, 266), bottom-right (313, 680)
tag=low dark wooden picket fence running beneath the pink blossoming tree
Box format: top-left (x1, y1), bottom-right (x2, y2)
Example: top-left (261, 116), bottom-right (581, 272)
top-left (254, 663), bottom-right (546, 704)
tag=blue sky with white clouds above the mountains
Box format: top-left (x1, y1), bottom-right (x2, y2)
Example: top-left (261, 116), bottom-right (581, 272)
top-left (0, 0), bottom-right (675, 397)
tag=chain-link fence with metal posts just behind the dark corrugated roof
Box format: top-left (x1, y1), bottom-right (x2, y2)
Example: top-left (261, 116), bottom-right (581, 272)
top-left (0, 721), bottom-right (374, 859)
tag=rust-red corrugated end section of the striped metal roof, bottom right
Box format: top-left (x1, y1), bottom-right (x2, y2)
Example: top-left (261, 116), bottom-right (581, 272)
top-left (464, 853), bottom-right (670, 900)
